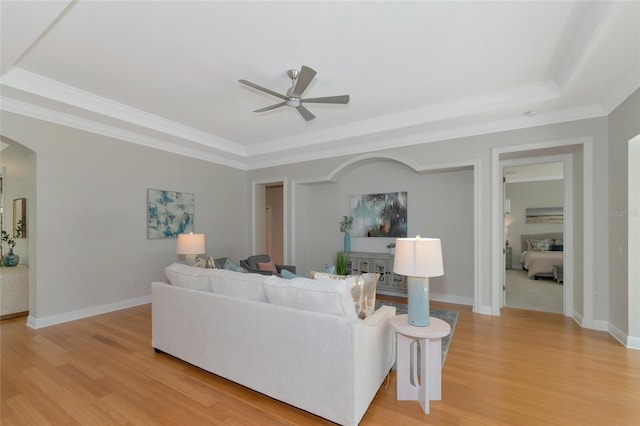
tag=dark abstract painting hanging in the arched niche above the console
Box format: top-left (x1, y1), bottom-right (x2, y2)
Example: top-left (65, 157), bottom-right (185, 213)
top-left (350, 192), bottom-right (407, 238)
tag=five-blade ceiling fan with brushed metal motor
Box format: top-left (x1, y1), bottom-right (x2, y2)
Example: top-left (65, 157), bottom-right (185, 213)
top-left (238, 65), bottom-right (349, 121)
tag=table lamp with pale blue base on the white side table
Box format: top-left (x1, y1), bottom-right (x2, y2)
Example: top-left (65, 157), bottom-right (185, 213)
top-left (393, 235), bottom-right (444, 327)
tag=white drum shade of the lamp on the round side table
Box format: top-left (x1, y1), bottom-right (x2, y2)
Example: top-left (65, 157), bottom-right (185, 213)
top-left (393, 236), bottom-right (444, 277)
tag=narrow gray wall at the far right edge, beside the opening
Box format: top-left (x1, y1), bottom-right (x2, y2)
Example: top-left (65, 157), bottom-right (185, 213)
top-left (598, 90), bottom-right (640, 338)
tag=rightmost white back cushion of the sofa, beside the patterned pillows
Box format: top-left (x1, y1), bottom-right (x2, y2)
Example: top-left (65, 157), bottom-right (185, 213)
top-left (264, 275), bottom-right (357, 318)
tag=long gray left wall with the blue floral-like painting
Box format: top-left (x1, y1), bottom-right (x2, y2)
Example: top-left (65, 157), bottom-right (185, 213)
top-left (2, 112), bottom-right (248, 318)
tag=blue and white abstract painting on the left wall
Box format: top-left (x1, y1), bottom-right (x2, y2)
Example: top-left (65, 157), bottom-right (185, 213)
top-left (147, 189), bottom-right (194, 238)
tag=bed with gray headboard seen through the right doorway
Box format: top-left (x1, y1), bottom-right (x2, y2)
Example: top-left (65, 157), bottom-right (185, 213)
top-left (520, 232), bottom-right (564, 279)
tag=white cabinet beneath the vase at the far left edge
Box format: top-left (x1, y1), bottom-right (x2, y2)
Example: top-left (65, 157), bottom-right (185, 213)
top-left (0, 264), bottom-right (29, 319)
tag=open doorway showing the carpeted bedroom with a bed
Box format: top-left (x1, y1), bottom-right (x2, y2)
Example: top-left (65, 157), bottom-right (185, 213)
top-left (503, 157), bottom-right (565, 314)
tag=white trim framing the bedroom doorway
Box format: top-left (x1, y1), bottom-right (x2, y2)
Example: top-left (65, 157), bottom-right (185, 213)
top-left (491, 137), bottom-right (592, 330)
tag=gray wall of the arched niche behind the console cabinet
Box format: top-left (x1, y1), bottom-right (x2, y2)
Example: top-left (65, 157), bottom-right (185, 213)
top-left (294, 161), bottom-right (473, 304)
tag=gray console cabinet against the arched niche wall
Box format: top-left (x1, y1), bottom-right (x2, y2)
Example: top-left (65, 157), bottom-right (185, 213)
top-left (347, 251), bottom-right (407, 296)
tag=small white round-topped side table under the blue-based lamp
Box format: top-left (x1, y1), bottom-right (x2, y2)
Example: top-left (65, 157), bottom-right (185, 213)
top-left (390, 315), bottom-right (451, 414)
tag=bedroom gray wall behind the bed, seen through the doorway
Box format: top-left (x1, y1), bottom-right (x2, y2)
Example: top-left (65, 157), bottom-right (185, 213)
top-left (505, 180), bottom-right (564, 268)
